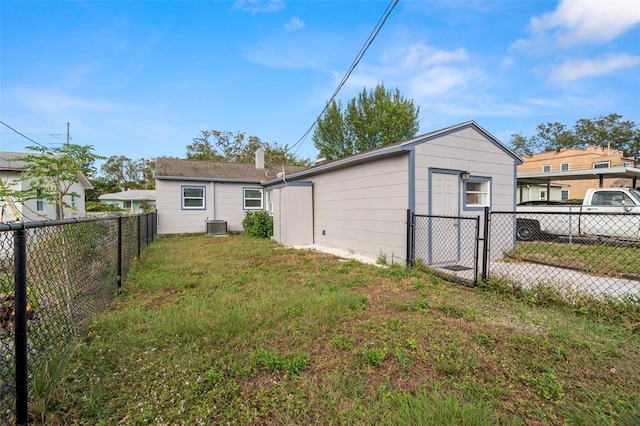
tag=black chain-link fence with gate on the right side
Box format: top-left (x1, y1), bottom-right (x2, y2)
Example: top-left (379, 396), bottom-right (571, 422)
top-left (407, 208), bottom-right (640, 305)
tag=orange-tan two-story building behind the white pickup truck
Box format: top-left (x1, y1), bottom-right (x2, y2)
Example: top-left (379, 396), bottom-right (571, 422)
top-left (518, 145), bottom-right (635, 201)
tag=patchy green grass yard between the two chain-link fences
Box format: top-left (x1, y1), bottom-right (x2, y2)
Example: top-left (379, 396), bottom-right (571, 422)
top-left (34, 235), bottom-right (640, 425)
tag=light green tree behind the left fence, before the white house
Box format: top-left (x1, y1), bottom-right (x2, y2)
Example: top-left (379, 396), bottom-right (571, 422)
top-left (12, 144), bottom-right (104, 219)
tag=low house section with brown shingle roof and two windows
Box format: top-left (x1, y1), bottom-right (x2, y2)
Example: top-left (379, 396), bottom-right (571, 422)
top-left (155, 150), bottom-right (303, 234)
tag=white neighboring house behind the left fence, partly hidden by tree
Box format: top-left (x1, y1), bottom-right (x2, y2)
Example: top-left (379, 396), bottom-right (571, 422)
top-left (0, 151), bottom-right (93, 222)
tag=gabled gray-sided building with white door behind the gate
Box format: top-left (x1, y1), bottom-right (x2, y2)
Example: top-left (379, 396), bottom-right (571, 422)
top-left (263, 121), bottom-right (521, 264)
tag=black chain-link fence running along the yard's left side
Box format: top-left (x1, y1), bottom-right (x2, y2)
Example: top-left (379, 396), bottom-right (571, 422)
top-left (0, 213), bottom-right (157, 425)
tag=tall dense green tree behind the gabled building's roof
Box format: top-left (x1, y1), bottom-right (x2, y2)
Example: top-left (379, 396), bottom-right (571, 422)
top-left (313, 83), bottom-right (420, 160)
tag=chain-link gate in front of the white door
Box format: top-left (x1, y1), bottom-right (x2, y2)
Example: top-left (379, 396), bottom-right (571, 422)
top-left (409, 215), bottom-right (480, 285)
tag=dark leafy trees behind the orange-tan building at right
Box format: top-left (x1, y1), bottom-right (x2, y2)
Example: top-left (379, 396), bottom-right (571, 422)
top-left (510, 114), bottom-right (640, 162)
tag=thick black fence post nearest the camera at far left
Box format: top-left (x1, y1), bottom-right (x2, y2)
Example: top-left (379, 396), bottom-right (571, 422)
top-left (13, 228), bottom-right (29, 425)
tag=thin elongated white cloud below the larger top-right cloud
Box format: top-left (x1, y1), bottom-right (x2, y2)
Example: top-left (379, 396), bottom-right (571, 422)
top-left (551, 53), bottom-right (640, 82)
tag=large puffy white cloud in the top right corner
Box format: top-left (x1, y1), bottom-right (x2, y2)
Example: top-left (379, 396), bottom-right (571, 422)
top-left (512, 0), bottom-right (640, 48)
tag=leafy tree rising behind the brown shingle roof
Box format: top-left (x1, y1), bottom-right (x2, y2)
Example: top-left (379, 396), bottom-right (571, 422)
top-left (186, 130), bottom-right (310, 166)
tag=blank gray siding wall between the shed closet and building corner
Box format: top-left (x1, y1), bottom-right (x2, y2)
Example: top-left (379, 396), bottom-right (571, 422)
top-left (313, 154), bottom-right (409, 263)
